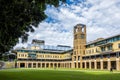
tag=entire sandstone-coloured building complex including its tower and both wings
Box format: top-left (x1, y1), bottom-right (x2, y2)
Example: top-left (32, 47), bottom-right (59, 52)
top-left (17, 24), bottom-right (120, 70)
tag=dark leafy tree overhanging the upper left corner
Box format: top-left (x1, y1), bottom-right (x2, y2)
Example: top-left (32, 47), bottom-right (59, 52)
top-left (0, 0), bottom-right (65, 53)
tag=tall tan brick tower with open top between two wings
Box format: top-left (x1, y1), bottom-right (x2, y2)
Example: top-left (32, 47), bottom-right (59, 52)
top-left (72, 24), bottom-right (86, 68)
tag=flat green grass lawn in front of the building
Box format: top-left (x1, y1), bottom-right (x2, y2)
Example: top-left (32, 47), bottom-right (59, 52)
top-left (0, 69), bottom-right (120, 80)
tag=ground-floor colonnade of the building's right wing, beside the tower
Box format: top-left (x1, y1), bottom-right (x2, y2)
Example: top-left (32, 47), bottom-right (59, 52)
top-left (73, 58), bottom-right (120, 70)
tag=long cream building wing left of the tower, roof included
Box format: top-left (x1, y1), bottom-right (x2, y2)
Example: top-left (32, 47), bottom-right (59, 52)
top-left (17, 44), bottom-right (72, 68)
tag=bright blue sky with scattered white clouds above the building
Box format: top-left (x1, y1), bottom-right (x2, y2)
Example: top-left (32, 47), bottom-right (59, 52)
top-left (15, 0), bottom-right (120, 47)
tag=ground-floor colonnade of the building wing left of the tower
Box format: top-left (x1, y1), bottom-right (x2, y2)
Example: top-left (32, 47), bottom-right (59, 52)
top-left (17, 61), bottom-right (71, 68)
